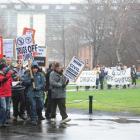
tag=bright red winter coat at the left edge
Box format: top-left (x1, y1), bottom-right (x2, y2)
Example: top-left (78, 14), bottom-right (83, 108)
top-left (0, 71), bottom-right (12, 97)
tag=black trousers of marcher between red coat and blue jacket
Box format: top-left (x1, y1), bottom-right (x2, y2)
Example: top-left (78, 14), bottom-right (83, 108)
top-left (12, 92), bottom-right (25, 117)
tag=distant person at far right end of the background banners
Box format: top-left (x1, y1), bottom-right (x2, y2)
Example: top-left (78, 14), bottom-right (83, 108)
top-left (131, 65), bottom-right (137, 86)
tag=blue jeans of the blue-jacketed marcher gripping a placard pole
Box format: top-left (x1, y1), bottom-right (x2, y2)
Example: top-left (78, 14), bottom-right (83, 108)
top-left (28, 97), bottom-right (43, 121)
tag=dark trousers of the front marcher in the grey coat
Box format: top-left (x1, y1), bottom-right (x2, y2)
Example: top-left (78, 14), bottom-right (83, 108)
top-left (51, 98), bottom-right (68, 119)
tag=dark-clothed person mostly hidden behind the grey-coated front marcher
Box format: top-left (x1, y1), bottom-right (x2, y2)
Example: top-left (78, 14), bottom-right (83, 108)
top-left (44, 63), bottom-right (54, 119)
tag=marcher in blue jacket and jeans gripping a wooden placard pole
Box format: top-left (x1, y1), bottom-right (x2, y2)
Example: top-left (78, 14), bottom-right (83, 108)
top-left (22, 61), bottom-right (45, 125)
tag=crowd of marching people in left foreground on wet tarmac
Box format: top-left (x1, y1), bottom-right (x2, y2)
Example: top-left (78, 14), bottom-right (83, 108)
top-left (0, 58), bottom-right (71, 128)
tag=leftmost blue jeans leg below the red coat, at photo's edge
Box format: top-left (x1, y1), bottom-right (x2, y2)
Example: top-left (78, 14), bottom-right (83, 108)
top-left (0, 97), bottom-right (7, 125)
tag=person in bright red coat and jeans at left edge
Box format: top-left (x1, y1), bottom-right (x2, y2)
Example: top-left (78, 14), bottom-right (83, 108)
top-left (0, 59), bottom-right (12, 127)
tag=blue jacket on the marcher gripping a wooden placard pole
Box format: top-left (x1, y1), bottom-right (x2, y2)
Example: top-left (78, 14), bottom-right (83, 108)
top-left (21, 72), bottom-right (46, 97)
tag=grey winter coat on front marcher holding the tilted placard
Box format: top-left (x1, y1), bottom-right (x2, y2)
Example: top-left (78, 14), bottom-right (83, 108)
top-left (49, 71), bottom-right (66, 99)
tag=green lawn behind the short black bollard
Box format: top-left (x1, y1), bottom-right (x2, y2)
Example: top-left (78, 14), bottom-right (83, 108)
top-left (67, 88), bottom-right (140, 114)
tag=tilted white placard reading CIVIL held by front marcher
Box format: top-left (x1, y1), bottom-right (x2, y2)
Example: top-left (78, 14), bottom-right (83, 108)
top-left (64, 56), bottom-right (85, 82)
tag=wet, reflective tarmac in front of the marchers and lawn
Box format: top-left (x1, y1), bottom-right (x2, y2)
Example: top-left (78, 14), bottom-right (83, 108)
top-left (0, 111), bottom-right (140, 140)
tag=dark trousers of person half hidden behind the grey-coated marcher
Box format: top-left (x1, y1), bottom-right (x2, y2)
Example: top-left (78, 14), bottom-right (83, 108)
top-left (44, 90), bottom-right (52, 119)
